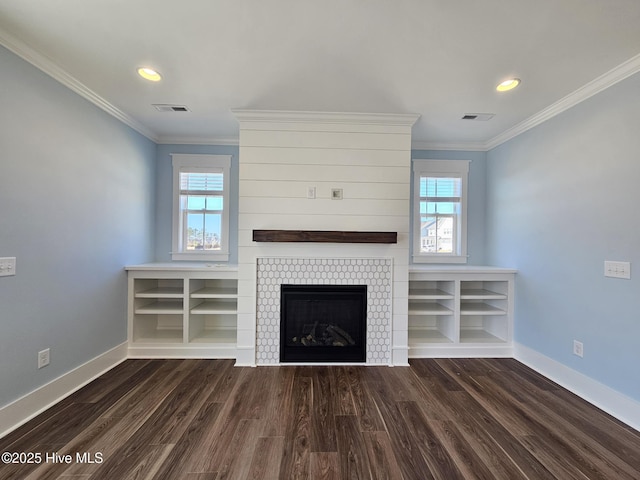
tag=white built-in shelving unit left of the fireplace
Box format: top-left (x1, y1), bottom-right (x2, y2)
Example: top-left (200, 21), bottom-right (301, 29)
top-left (127, 263), bottom-right (238, 358)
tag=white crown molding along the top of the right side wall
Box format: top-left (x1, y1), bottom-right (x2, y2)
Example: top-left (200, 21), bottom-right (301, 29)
top-left (485, 54), bottom-right (640, 150)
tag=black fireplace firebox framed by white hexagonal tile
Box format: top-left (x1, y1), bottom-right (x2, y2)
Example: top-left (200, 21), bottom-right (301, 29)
top-left (280, 284), bottom-right (367, 363)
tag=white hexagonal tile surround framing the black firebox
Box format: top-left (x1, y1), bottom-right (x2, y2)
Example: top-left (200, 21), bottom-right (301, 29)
top-left (256, 257), bottom-right (393, 365)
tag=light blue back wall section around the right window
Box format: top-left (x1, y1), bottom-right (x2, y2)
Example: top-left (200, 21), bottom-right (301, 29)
top-left (411, 150), bottom-right (486, 265)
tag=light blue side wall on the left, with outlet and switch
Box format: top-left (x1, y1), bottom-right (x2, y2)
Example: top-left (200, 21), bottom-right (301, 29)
top-left (0, 47), bottom-right (156, 407)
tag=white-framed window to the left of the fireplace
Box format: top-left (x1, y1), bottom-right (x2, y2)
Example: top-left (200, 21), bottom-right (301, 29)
top-left (172, 155), bottom-right (231, 261)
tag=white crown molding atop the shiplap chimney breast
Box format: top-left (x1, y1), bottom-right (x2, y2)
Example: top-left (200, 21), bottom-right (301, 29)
top-left (231, 108), bottom-right (420, 127)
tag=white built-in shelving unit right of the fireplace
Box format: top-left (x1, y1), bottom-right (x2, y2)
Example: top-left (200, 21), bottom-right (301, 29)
top-left (408, 266), bottom-right (515, 357)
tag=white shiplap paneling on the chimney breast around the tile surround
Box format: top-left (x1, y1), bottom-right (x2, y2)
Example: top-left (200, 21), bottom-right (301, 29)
top-left (232, 111), bottom-right (416, 364)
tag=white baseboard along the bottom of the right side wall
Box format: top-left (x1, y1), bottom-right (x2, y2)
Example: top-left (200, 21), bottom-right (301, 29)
top-left (514, 343), bottom-right (640, 431)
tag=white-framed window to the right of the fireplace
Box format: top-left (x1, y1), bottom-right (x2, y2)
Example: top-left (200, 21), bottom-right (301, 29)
top-left (413, 160), bottom-right (469, 263)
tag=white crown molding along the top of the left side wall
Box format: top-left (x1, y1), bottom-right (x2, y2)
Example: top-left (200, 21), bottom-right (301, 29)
top-left (0, 29), bottom-right (157, 142)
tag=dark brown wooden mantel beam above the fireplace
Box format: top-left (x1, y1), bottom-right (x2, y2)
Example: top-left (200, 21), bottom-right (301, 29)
top-left (253, 230), bottom-right (398, 243)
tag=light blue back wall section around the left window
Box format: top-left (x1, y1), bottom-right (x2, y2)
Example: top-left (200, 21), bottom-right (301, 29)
top-left (155, 145), bottom-right (239, 263)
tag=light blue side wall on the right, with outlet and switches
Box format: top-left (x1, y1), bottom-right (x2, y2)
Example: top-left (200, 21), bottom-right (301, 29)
top-left (486, 74), bottom-right (640, 400)
